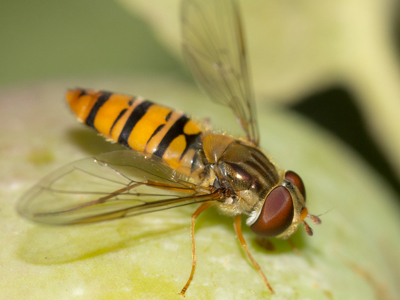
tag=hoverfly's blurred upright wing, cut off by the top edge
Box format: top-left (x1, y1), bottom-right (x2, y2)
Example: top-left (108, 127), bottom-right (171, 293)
top-left (181, 0), bottom-right (259, 145)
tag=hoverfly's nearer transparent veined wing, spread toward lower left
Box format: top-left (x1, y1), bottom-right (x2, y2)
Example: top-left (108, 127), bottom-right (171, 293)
top-left (17, 150), bottom-right (221, 225)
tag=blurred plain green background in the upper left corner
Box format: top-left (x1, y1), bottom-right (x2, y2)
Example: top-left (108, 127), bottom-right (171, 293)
top-left (0, 0), bottom-right (187, 86)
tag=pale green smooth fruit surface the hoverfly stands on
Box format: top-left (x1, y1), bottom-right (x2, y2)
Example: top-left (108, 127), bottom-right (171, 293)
top-left (0, 76), bottom-right (400, 299)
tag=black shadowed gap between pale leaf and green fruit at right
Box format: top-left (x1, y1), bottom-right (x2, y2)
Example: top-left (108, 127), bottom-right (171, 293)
top-left (290, 87), bottom-right (400, 199)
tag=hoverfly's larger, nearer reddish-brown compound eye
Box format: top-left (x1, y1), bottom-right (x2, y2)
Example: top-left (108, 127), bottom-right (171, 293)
top-left (250, 186), bottom-right (294, 237)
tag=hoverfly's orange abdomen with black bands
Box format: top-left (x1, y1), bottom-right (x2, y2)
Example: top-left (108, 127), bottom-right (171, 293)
top-left (67, 89), bottom-right (202, 170)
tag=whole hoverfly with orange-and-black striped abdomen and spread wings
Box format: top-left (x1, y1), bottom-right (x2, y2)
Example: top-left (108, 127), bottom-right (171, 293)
top-left (17, 0), bottom-right (321, 296)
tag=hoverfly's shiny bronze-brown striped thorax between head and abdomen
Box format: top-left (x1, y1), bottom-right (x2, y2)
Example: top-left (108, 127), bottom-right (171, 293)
top-left (203, 134), bottom-right (280, 215)
